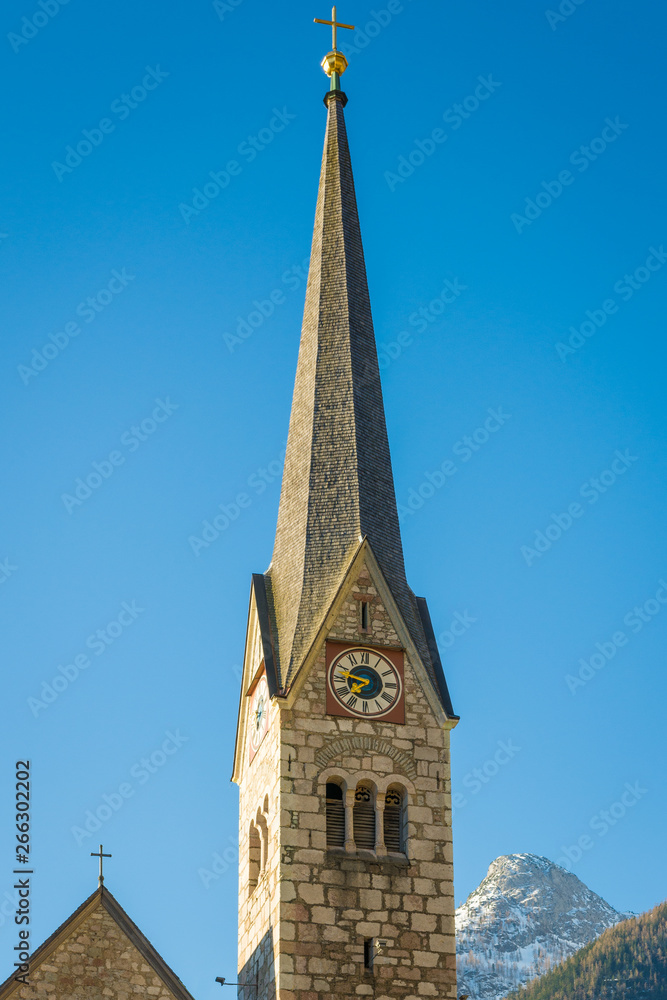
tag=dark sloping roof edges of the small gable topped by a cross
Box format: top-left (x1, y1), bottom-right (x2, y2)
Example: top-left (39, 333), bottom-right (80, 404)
top-left (0, 886), bottom-right (194, 1000)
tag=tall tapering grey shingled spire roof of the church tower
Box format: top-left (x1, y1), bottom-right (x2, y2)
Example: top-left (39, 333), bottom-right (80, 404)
top-left (266, 91), bottom-right (435, 691)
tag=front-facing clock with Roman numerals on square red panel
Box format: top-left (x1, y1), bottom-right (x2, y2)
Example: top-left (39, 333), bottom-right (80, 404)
top-left (327, 646), bottom-right (403, 722)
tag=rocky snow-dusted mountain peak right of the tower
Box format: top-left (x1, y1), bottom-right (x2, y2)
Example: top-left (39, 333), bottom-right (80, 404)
top-left (456, 854), bottom-right (629, 1000)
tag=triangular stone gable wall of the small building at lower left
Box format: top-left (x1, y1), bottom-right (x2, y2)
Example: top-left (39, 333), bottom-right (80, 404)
top-left (0, 889), bottom-right (192, 1000)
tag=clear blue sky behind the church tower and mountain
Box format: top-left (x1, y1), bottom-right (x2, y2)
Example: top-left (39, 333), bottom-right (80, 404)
top-left (0, 0), bottom-right (667, 1000)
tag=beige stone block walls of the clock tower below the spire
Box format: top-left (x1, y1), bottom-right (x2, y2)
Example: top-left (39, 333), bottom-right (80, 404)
top-left (232, 564), bottom-right (456, 1000)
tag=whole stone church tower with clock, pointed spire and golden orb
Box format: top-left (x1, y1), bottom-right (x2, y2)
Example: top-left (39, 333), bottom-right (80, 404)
top-left (233, 17), bottom-right (458, 1000)
